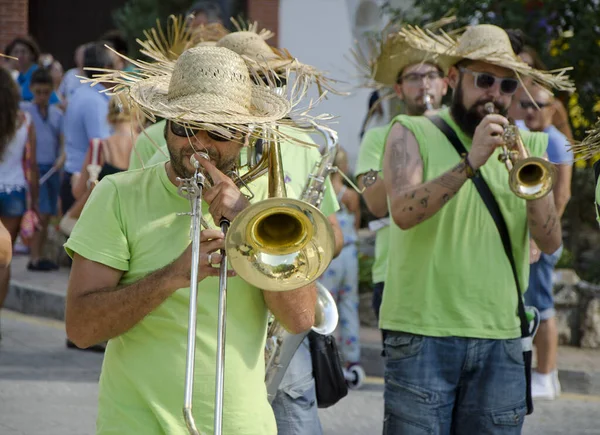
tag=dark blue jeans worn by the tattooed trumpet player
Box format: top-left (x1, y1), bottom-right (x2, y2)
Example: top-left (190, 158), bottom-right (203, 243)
top-left (383, 331), bottom-right (527, 435)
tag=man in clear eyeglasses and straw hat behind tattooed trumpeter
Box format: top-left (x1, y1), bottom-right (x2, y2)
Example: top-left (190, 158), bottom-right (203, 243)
top-left (355, 38), bottom-right (448, 334)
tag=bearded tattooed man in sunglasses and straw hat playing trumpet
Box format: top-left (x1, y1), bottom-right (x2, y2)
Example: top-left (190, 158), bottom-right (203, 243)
top-left (380, 25), bottom-right (570, 434)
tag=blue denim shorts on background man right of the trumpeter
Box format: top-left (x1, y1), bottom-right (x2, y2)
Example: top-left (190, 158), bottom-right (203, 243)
top-left (524, 246), bottom-right (563, 320)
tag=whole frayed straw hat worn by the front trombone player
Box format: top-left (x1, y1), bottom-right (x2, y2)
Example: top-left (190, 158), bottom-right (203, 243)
top-left (90, 46), bottom-right (292, 138)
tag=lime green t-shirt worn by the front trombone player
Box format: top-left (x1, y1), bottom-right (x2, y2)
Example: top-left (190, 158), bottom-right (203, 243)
top-left (65, 165), bottom-right (277, 435)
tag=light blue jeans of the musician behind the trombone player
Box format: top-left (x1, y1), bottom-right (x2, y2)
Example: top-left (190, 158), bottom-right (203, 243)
top-left (271, 338), bottom-right (323, 435)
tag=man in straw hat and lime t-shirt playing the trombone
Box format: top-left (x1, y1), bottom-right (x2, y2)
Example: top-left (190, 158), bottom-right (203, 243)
top-left (65, 47), bottom-right (324, 435)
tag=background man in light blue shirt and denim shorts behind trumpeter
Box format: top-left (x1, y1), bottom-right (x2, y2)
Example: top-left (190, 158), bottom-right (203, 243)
top-left (516, 85), bottom-right (573, 400)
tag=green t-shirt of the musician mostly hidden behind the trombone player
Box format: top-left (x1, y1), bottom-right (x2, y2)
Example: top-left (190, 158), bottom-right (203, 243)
top-left (144, 127), bottom-right (340, 216)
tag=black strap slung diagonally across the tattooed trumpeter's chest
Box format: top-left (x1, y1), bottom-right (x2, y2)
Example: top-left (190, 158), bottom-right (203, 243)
top-left (428, 115), bottom-right (533, 414)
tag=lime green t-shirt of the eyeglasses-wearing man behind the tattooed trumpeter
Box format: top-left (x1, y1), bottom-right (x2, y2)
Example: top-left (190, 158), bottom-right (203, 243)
top-left (354, 125), bottom-right (393, 283)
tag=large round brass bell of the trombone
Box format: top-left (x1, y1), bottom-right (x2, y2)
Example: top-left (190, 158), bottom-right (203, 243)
top-left (225, 198), bottom-right (335, 291)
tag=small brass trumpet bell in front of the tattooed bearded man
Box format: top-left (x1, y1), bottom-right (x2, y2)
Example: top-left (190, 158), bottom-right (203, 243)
top-left (509, 157), bottom-right (556, 200)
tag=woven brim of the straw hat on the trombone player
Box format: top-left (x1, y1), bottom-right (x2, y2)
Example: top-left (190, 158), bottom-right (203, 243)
top-left (129, 75), bottom-right (291, 125)
